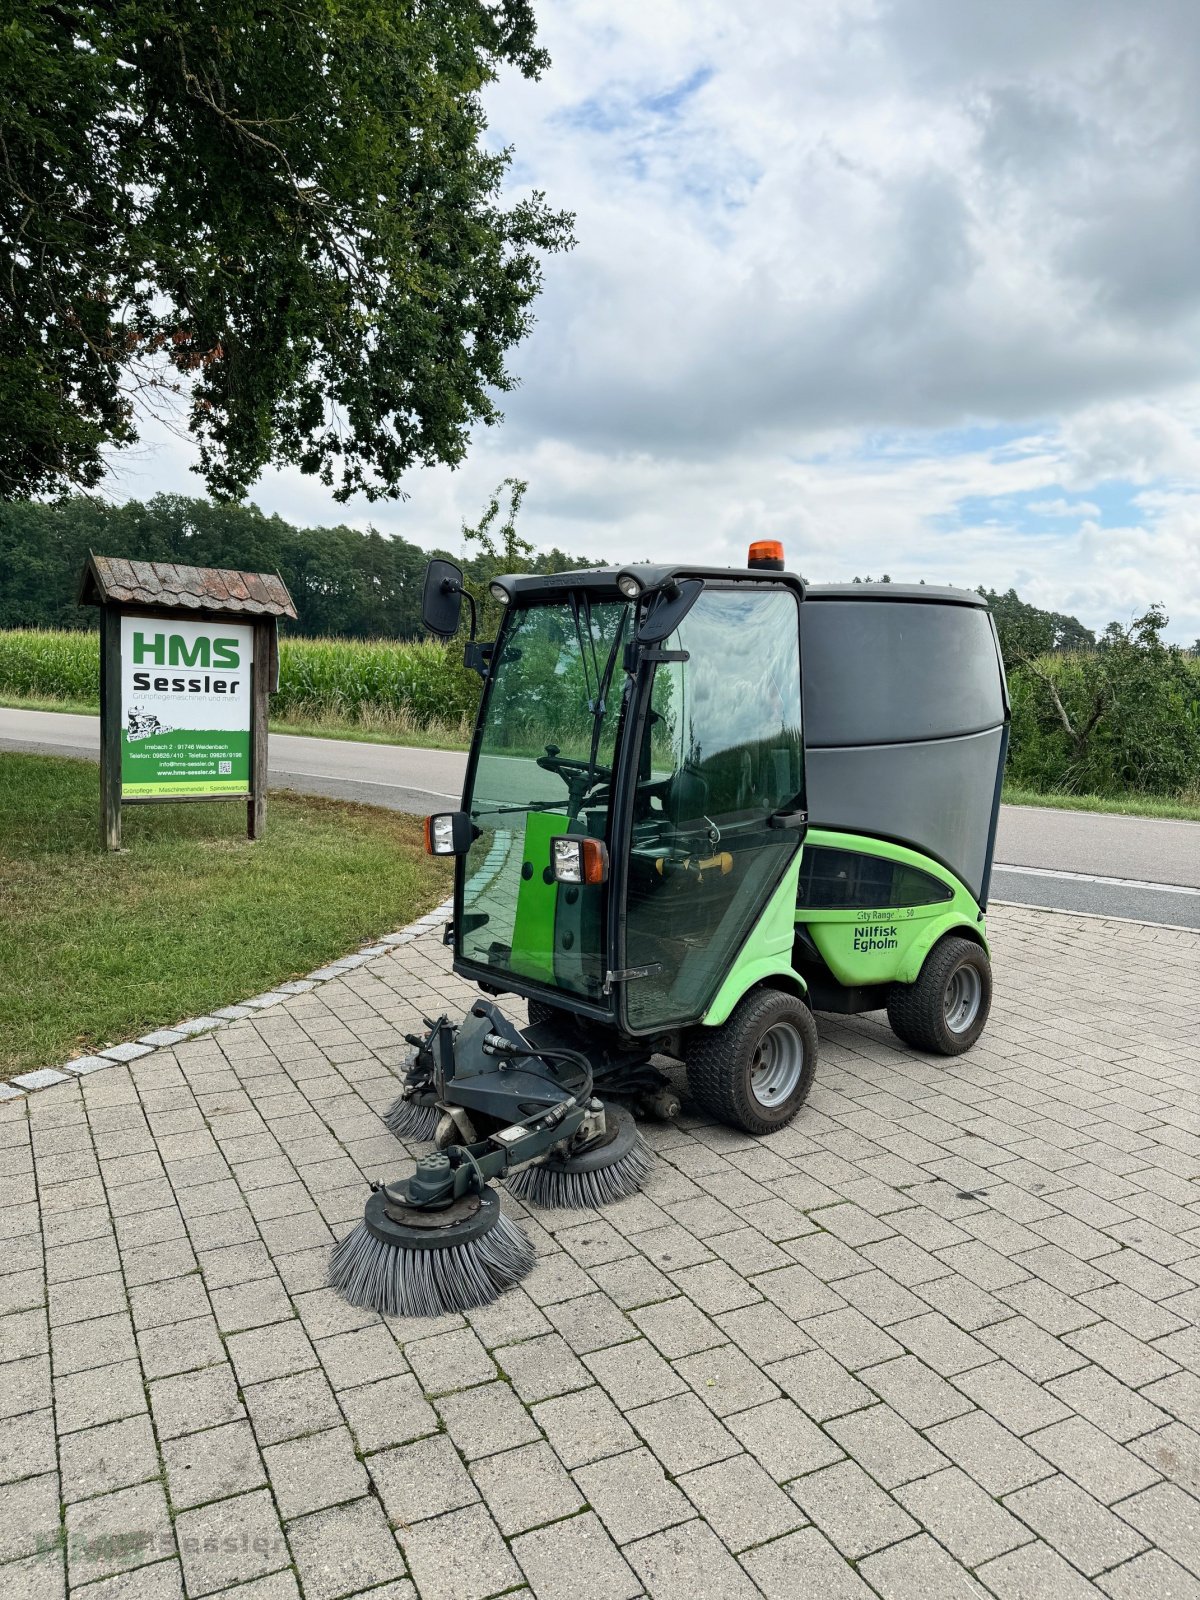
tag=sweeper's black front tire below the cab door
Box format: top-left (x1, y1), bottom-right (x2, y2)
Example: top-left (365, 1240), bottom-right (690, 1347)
top-left (685, 989), bottom-right (818, 1133)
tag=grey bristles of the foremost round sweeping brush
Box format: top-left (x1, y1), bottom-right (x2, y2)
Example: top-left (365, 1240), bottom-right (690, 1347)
top-left (326, 1189), bottom-right (538, 1317)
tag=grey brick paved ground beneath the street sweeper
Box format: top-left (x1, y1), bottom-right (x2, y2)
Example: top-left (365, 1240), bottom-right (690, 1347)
top-left (0, 909), bottom-right (1200, 1600)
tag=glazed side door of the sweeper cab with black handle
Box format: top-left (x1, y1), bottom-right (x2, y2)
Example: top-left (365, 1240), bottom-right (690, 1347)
top-left (618, 584), bottom-right (805, 1034)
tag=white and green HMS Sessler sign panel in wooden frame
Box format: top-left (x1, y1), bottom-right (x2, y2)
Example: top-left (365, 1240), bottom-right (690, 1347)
top-left (122, 616), bottom-right (254, 798)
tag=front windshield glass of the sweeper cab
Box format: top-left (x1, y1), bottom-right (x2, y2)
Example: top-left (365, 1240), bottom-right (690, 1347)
top-left (456, 592), bottom-right (630, 1000)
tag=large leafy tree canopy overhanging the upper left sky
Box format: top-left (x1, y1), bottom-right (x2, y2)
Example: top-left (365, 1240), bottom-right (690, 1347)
top-left (0, 0), bottom-right (571, 499)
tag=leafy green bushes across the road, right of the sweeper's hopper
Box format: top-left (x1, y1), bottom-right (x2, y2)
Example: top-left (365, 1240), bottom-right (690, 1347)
top-left (1008, 608), bottom-right (1200, 800)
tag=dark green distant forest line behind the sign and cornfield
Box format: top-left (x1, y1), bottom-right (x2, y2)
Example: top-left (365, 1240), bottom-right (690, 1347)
top-left (0, 494), bottom-right (601, 638)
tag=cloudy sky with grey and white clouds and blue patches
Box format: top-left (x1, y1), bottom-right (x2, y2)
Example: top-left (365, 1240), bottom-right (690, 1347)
top-left (114, 0), bottom-right (1200, 643)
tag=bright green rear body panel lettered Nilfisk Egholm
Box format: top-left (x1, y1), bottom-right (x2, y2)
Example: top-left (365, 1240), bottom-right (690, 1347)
top-left (795, 829), bottom-right (987, 986)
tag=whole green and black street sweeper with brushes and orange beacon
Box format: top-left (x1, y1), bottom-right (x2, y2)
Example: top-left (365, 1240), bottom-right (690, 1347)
top-left (330, 542), bottom-right (1008, 1315)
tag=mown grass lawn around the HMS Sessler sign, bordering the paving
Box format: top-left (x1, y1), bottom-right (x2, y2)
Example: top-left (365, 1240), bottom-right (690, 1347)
top-left (0, 754), bottom-right (451, 1078)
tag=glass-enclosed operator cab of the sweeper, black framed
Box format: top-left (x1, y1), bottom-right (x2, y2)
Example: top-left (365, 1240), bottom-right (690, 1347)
top-left (419, 566), bottom-right (805, 1038)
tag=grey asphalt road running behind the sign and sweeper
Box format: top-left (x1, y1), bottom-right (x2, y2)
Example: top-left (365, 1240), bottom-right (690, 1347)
top-left (0, 707), bottom-right (1200, 928)
